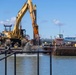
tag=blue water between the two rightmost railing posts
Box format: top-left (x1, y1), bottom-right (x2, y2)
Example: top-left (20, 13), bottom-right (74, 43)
top-left (40, 55), bottom-right (50, 75)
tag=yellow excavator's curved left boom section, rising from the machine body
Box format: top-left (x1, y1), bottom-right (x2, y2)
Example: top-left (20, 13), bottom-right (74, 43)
top-left (12, 3), bottom-right (28, 37)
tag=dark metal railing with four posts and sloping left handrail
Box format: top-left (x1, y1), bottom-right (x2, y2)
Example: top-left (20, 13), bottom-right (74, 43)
top-left (0, 50), bottom-right (52, 75)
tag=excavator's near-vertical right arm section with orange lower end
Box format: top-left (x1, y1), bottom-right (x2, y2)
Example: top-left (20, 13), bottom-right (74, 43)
top-left (28, 0), bottom-right (39, 39)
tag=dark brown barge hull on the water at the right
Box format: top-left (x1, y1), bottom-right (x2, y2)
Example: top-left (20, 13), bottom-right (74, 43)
top-left (53, 46), bottom-right (76, 56)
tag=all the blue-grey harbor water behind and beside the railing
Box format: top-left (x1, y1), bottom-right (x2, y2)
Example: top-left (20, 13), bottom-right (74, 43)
top-left (0, 51), bottom-right (76, 75)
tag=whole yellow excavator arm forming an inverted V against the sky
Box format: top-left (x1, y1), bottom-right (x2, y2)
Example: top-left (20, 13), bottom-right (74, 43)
top-left (12, 0), bottom-right (39, 39)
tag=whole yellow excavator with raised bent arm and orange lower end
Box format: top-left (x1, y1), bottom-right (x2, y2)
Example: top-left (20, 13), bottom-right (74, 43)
top-left (2, 0), bottom-right (39, 45)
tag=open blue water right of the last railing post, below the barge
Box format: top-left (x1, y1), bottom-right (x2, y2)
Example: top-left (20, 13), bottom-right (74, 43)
top-left (52, 56), bottom-right (76, 75)
